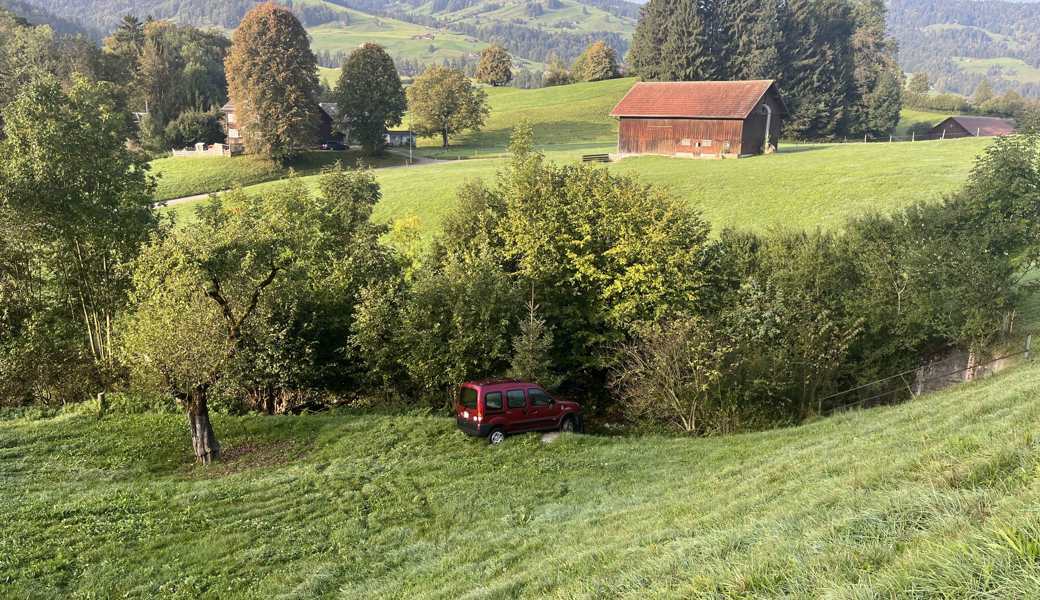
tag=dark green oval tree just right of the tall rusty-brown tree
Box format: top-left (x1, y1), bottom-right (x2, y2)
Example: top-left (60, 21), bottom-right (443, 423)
top-left (334, 44), bottom-right (407, 154)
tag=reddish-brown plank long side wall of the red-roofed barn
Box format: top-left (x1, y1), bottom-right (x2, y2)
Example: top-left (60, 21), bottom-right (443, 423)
top-left (618, 118), bottom-right (744, 155)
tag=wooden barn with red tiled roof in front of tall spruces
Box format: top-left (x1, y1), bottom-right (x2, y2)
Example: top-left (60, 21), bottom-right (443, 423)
top-left (610, 79), bottom-right (787, 158)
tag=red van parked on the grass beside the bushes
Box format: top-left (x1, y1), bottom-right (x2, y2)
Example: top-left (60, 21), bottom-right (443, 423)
top-left (456, 380), bottom-right (582, 444)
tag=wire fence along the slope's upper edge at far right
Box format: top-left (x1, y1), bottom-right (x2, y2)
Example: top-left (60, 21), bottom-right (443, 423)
top-left (818, 335), bottom-right (1033, 416)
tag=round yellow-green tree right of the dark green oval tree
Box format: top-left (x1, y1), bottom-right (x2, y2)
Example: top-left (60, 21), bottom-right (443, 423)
top-left (408, 67), bottom-right (490, 148)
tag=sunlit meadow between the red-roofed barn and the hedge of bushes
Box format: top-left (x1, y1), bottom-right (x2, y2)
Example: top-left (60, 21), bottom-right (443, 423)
top-left (168, 138), bottom-right (989, 234)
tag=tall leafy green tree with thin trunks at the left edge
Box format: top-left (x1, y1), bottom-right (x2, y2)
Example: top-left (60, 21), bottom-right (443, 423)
top-left (0, 76), bottom-right (158, 400)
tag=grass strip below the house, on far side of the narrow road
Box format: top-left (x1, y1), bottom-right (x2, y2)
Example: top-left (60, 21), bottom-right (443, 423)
top-left (151, 151), bottom-right (404, 200)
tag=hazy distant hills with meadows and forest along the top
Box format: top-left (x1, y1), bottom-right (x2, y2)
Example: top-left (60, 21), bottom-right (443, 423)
top-left (14, 0), bottom-right (1040, 97)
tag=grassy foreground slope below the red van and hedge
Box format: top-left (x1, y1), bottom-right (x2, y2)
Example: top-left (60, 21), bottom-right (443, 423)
top-left (6, 357), bottom-right (1040, 600)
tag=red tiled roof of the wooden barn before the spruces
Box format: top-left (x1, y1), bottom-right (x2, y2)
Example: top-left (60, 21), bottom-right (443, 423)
top-left (610, 79), bottom-right (783, 119)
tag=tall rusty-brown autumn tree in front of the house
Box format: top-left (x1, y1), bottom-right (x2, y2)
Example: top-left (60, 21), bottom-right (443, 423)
top-left (225, 2), bottom-right (318, 161)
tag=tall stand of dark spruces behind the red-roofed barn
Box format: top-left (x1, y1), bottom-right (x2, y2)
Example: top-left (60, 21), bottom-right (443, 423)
top-left (628, 0), bottom-right (902, 138)
